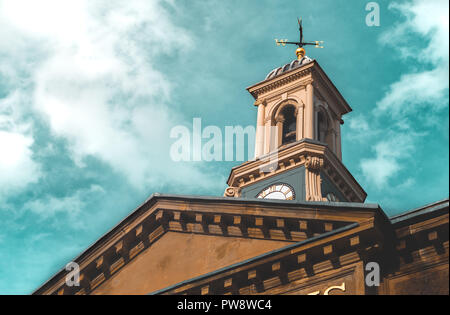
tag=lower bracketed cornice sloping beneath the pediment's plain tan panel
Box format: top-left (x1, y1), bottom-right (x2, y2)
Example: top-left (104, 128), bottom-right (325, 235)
top-left (152, 224), bottom-right (383, 295)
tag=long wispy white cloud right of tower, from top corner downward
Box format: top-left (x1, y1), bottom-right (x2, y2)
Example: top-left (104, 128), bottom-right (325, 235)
top-left (360, 0), bottom-right (449, 190)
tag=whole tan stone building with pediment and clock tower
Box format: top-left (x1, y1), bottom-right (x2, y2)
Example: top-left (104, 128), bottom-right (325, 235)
top-left (34, 50), bottom-right (449, 295)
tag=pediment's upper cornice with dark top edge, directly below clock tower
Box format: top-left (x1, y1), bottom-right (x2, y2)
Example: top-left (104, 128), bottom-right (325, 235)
top-left (34, 198), bottom-right (379, 295)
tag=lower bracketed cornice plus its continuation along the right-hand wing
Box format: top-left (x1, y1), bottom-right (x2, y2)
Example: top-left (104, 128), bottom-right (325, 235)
top-left (153, 206), bottom-right (449, 295)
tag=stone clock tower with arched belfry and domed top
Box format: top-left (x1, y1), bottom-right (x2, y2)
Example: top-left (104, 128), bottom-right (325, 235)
top-left (225, 47), bottom-right (367, 203)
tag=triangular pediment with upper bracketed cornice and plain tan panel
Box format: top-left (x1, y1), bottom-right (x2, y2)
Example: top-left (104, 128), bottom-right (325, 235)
top-left (35, 195), bottom-right (385, 294)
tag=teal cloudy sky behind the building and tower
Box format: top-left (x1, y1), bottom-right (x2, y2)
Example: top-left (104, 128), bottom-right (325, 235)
top-left (0, 0), bottom-right (449, 294)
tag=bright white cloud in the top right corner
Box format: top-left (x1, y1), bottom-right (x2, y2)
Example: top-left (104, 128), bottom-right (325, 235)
top-left (377, 0), bottom-right (449, 116)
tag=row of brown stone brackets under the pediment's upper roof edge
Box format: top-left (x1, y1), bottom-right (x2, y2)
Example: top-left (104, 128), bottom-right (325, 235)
top-left (33, 202), bottom-right (382, 295)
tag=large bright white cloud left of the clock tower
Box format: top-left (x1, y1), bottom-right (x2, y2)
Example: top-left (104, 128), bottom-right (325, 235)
top-left (0, 0), bottom-right (222, 200)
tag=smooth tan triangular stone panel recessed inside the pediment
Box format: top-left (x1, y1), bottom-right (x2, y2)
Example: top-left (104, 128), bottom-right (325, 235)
top-left (92, 232), bottom-right (289, 295)
